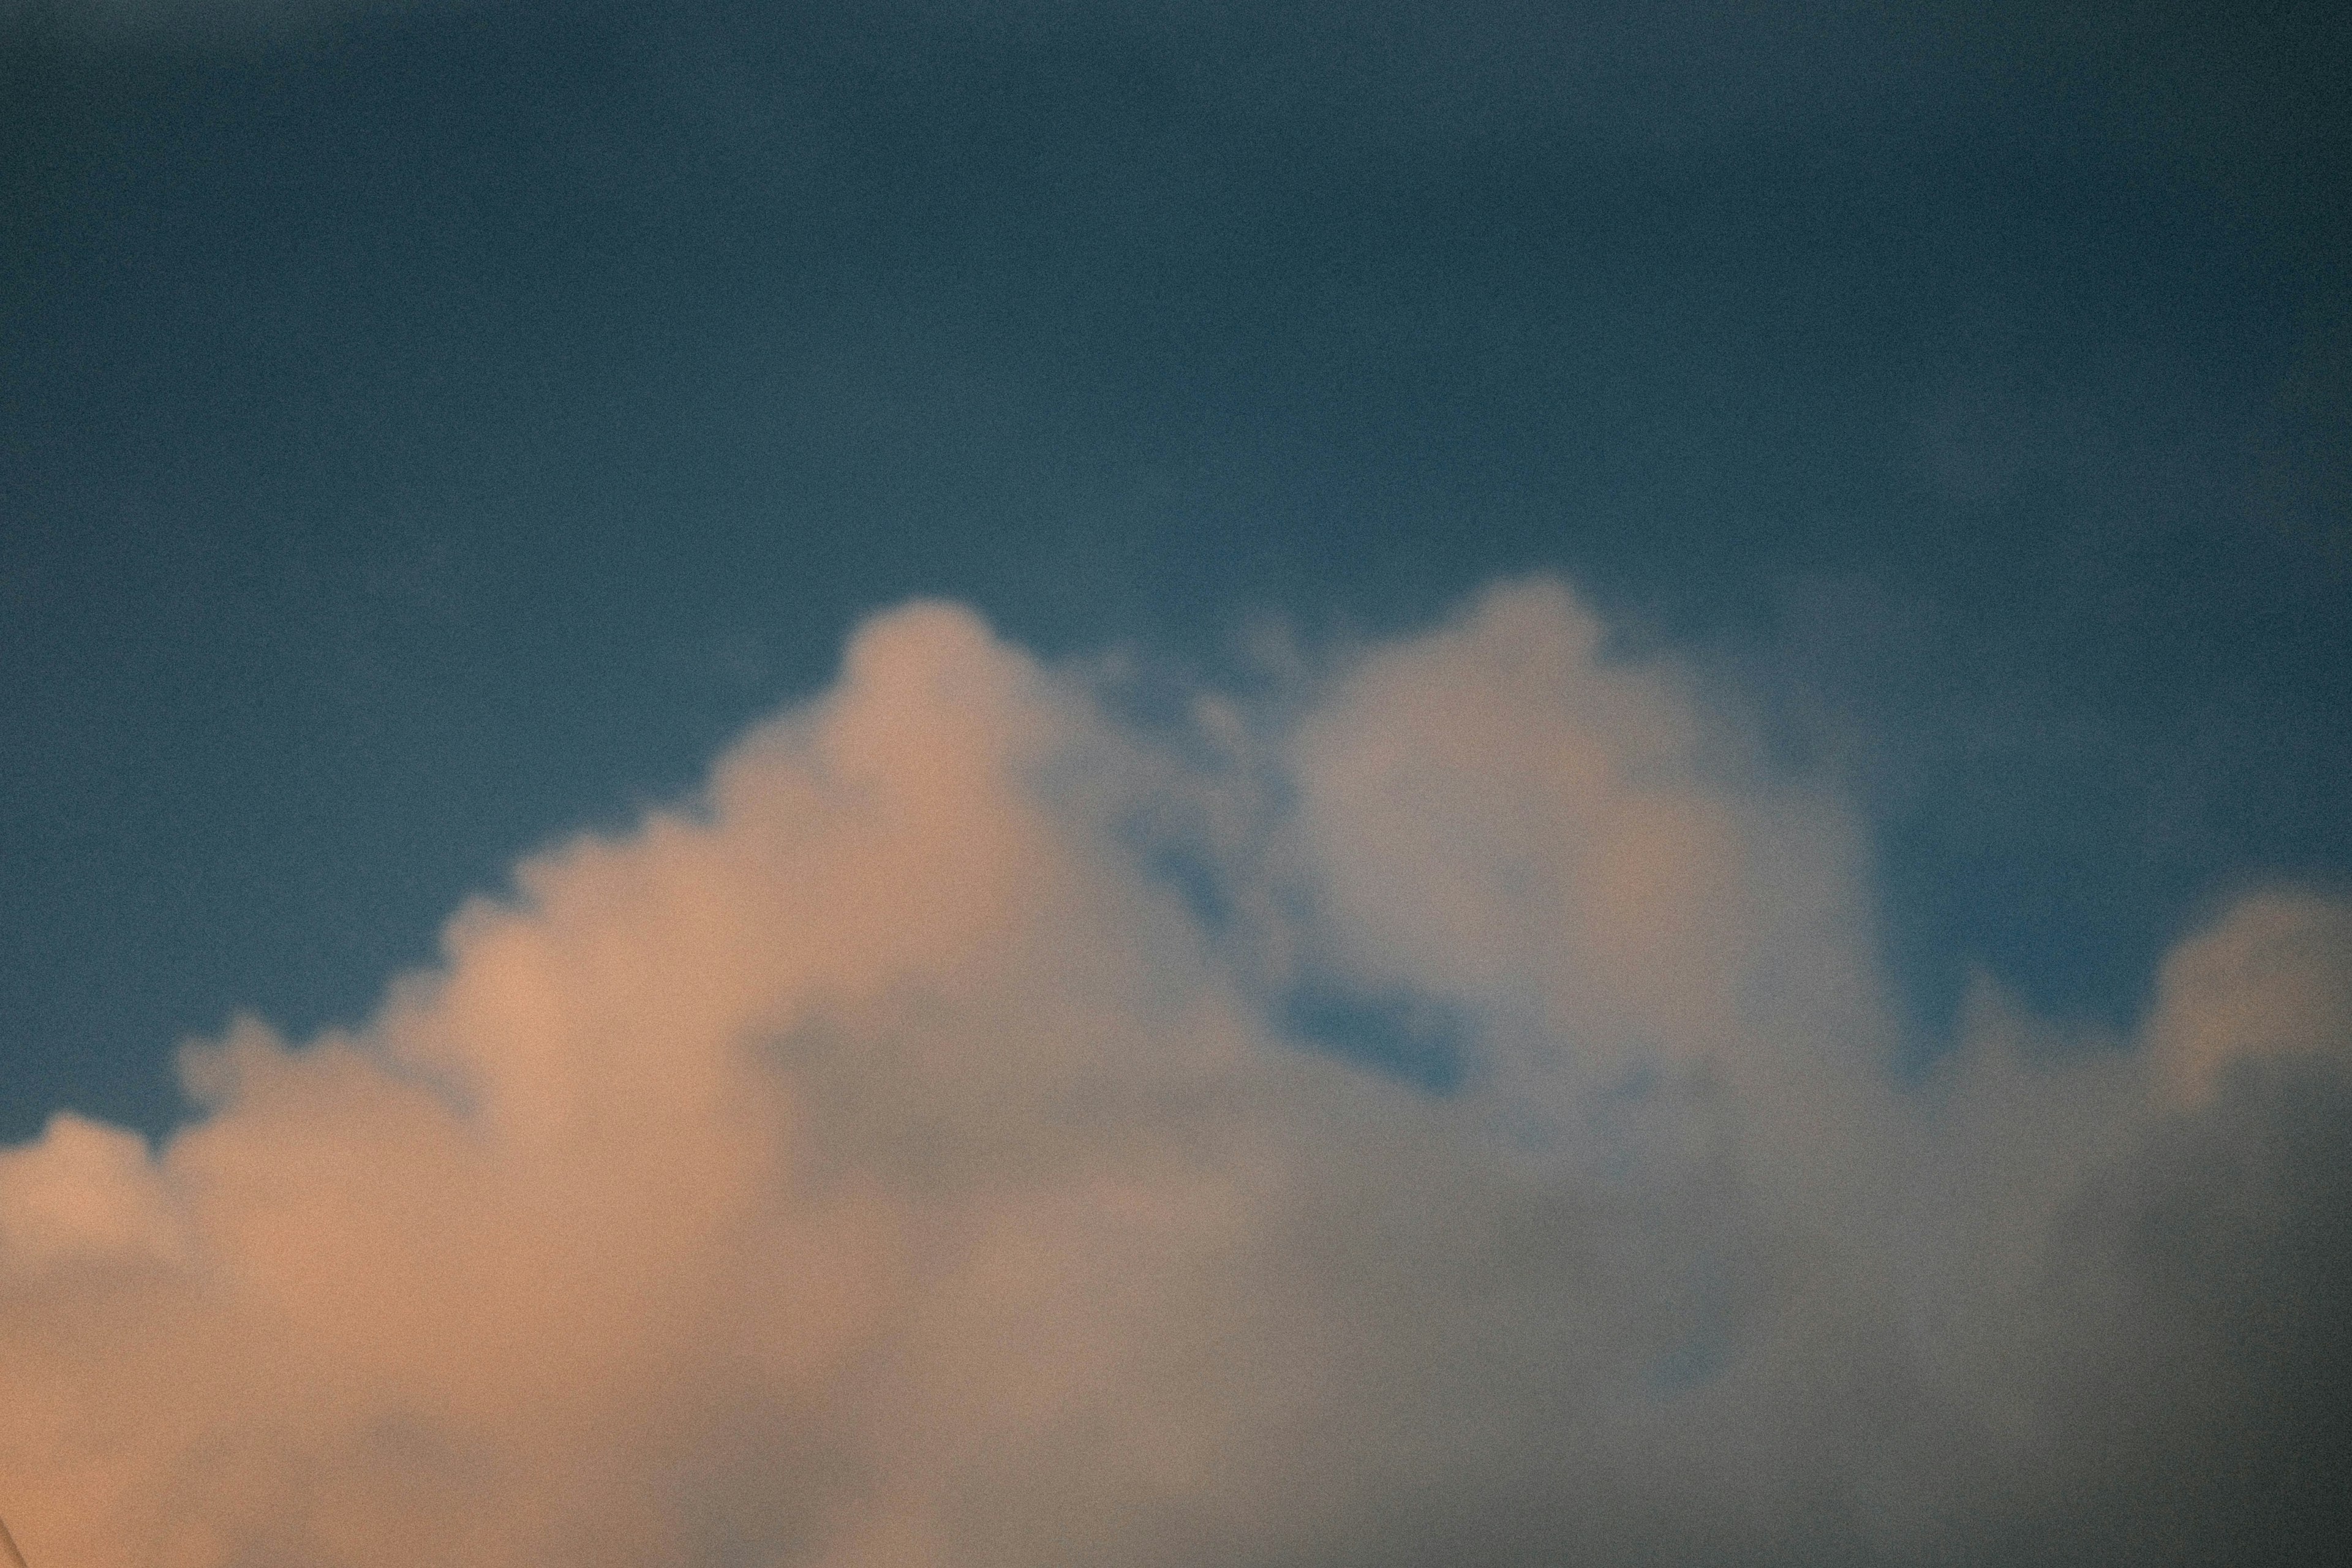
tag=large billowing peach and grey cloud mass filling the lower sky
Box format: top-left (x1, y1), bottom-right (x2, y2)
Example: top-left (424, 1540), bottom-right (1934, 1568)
top-left (0, 583), bottom-right (2352, 1568)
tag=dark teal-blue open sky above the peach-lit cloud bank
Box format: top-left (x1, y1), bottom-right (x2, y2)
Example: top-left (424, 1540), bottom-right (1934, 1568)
top-left (0, 0), bottom-right (2352, 1138)
